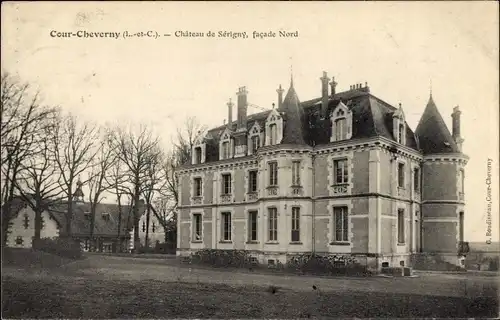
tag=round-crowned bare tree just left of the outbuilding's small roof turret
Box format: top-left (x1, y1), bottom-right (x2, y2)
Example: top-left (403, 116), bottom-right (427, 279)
top-left (53, 114), bottom-right (99, 237)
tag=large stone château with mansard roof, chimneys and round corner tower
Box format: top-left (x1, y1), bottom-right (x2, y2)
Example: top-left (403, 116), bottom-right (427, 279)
top-left (176, 72), bottom-right (468, 269)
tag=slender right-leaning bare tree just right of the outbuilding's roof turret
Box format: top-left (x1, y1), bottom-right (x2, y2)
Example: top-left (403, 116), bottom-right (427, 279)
top-left (87, 132), bottom-right (118, 250)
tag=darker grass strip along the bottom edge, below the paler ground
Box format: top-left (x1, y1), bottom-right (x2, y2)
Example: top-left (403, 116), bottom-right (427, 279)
top-left (2, 275), bottom-right (498, 319)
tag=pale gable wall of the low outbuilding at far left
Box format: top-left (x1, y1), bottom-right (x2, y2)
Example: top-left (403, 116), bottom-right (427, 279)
top-left (7, 207), bottom-right (59, 248)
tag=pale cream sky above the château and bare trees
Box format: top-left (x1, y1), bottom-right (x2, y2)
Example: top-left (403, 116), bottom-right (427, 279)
top-left (1, 1), bottom-right (499, 241)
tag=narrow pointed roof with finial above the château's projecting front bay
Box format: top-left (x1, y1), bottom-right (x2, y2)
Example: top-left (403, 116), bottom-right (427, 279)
top-left (280, 79), bottom-right (306, 145)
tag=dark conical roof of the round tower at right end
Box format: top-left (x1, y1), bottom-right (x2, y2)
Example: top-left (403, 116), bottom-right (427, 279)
top-left (415, 94), bottom-right (460, 154)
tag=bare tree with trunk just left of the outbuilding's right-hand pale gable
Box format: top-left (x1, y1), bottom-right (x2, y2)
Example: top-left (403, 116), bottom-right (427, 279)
top-left (115, 126), bottom-right (159, 250)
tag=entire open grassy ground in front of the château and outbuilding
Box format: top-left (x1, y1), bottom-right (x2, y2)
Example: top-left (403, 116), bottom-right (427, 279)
top-left (2, 251), bottom-right (498, 319)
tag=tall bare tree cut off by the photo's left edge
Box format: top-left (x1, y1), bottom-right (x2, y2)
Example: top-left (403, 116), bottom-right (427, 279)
top-left (0, 71), bottom-right (56, 245)
